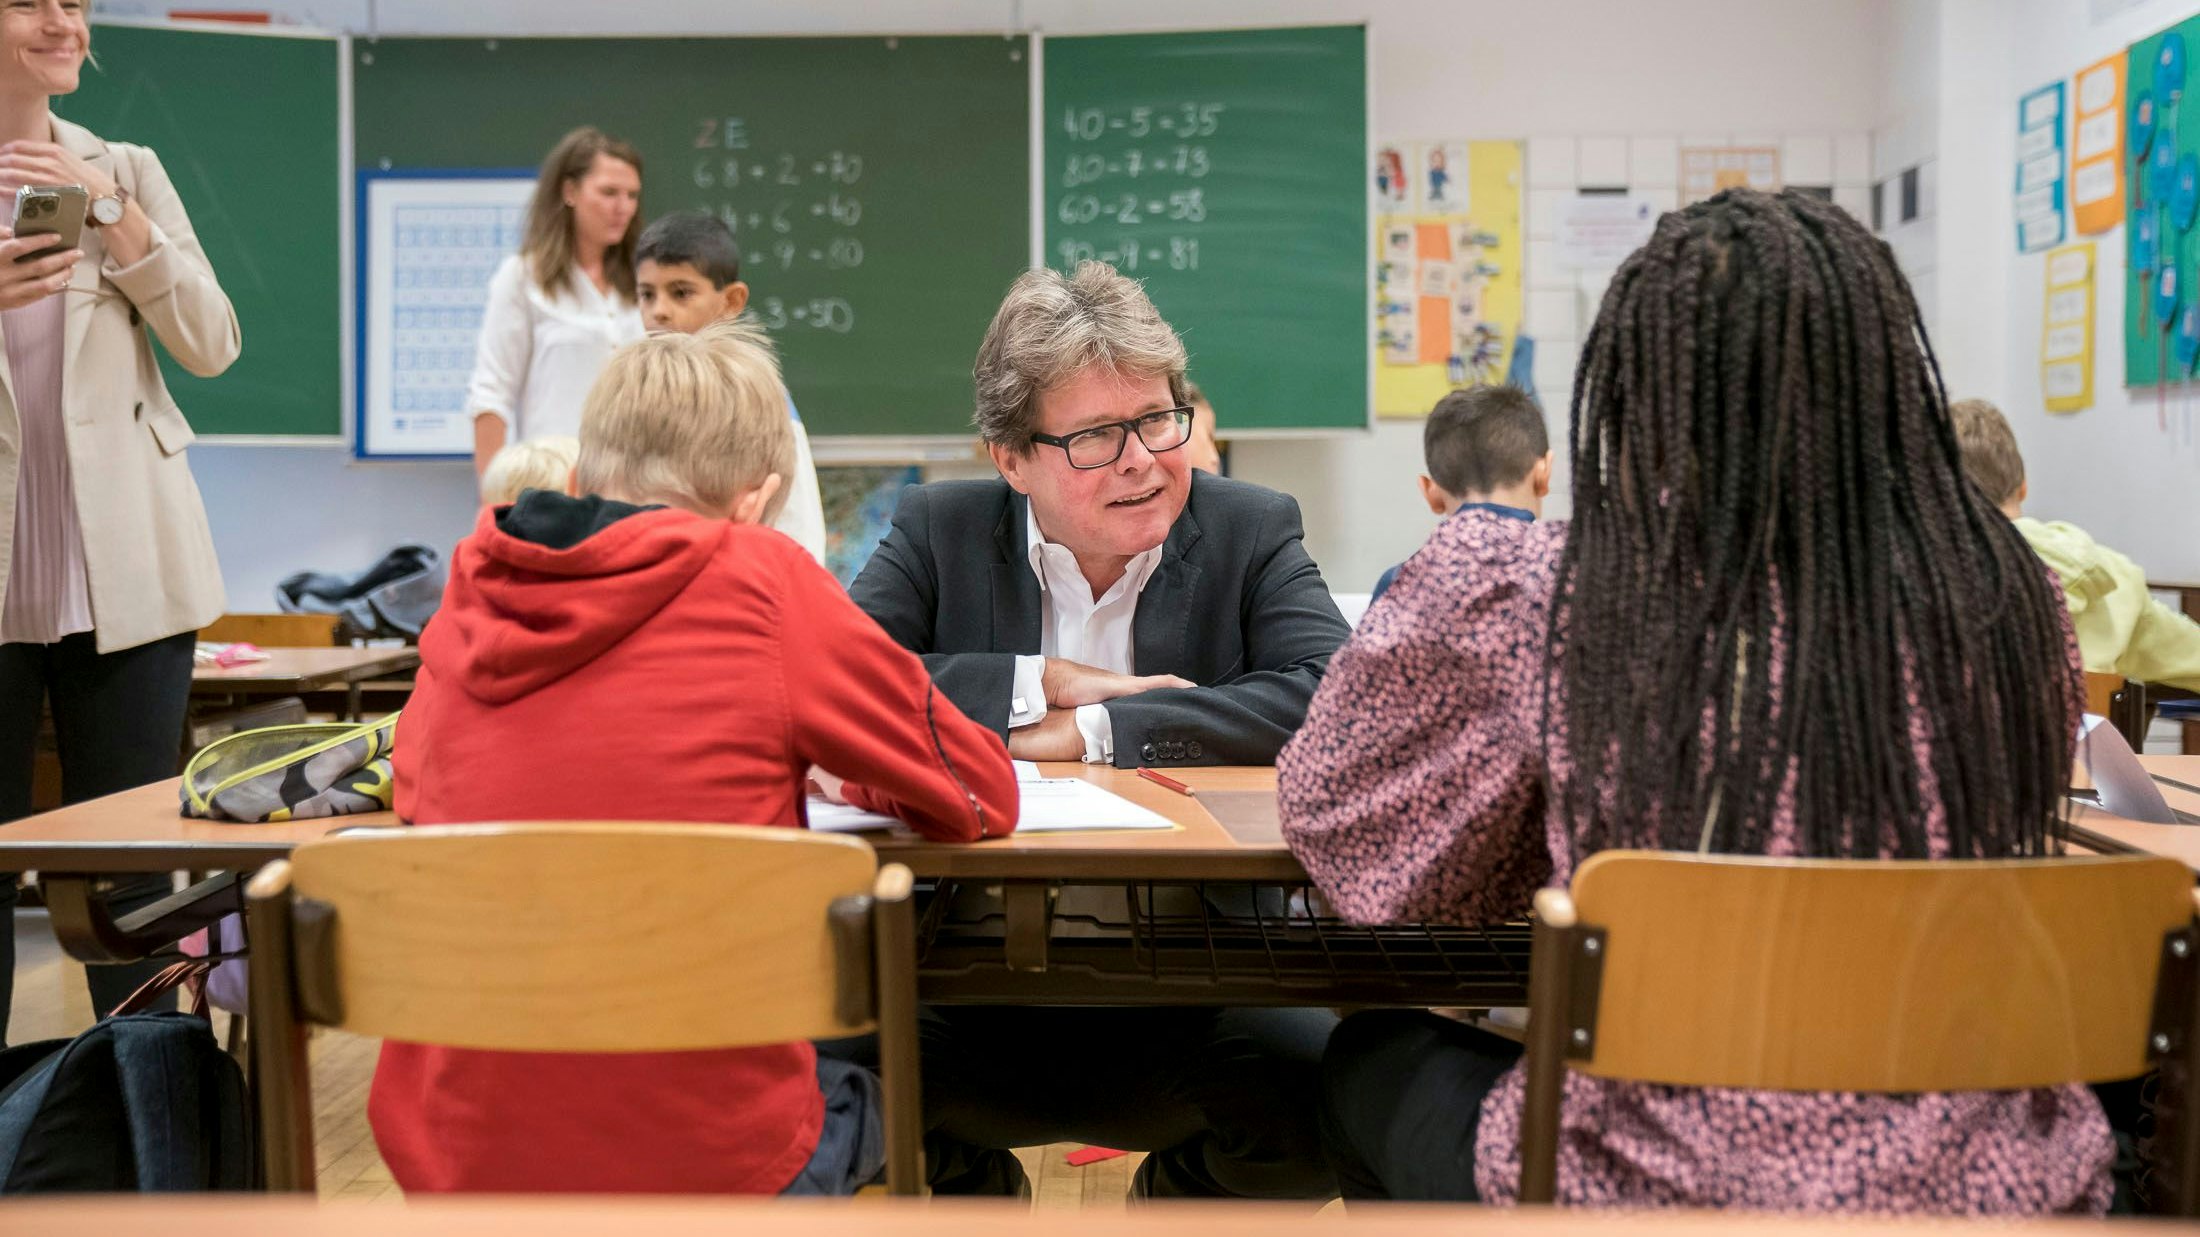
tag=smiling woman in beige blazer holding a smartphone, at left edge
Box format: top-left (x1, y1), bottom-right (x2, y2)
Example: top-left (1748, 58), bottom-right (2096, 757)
top-left (0, 0), bottom-right (240, 1037)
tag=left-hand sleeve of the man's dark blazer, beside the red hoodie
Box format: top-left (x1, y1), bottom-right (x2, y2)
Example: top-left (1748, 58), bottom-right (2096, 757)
top-left (849, 486), bottom-right (1020, 742)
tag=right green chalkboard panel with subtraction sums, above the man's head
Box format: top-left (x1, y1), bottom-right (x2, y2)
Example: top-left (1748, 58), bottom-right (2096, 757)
top-left (1041, 26), bottom-right (1371, 429)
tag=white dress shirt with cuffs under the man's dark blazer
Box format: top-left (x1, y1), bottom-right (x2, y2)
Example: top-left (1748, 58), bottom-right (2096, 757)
top-left (1008, 508), bottom-right (1162, 764)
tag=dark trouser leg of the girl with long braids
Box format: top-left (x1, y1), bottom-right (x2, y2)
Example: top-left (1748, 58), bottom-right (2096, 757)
top-left (1322, 1010), bottom-right (1520, 1202)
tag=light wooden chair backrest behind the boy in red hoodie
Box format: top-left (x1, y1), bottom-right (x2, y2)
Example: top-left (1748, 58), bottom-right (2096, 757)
top-left (290, 823), bottom-right (878, 1052)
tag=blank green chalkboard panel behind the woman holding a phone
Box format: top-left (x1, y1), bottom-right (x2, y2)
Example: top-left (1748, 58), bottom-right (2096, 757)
top-left (53, 24), bottom-right (345, 436)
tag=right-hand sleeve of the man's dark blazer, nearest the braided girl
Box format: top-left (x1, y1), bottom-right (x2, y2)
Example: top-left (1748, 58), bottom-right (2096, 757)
top-left (1108, 495), bottom-right (1353, 768)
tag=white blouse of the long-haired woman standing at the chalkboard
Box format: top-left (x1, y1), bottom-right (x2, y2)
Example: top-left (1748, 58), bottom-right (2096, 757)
top-left (466, 253), bottom-right (642, 442)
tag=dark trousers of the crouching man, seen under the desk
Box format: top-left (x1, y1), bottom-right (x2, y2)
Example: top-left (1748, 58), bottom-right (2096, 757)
top-left (920, 1006), bottom-right (1338, 1200)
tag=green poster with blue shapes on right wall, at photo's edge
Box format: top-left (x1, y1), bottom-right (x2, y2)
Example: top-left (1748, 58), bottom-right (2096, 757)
top-left (2123, 18), bottom-right (2200, 387)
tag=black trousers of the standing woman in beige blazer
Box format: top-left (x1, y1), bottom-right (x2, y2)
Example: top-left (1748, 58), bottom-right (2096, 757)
top-left (0, 632), bottom-right (196, 1041)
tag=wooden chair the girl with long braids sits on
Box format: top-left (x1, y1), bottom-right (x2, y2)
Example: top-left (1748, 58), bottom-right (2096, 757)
top-left (1520, 852), bottom-right (2200, 1215)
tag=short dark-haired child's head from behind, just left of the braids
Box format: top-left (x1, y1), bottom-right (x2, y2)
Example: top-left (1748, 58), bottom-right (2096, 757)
top-left (1421, 387), bottom-right (1551, 515)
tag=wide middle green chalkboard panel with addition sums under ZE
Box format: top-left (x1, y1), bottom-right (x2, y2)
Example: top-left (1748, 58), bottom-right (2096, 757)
top-left (352, 35), bottom-right (1032, 436)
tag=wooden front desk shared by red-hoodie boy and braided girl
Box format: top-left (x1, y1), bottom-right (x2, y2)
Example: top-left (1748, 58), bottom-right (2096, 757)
top-left (0, 764), bottom-right (1529, 1006)
